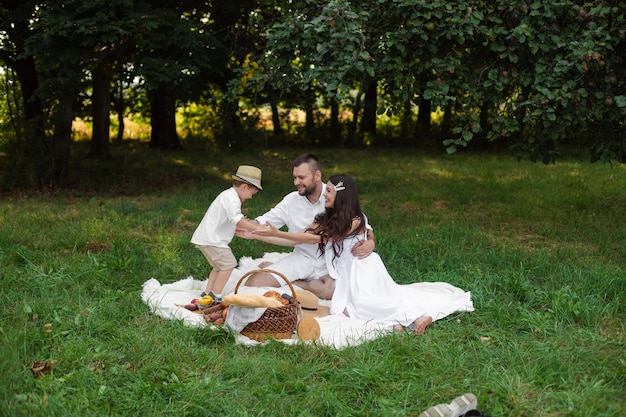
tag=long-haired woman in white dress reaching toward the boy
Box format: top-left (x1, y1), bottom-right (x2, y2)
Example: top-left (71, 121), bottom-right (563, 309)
top-left (253, 174), bottom-right (473, 335)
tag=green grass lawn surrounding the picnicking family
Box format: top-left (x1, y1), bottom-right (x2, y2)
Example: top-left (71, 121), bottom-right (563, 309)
top-left (0, 147), bottom-right (626, 417)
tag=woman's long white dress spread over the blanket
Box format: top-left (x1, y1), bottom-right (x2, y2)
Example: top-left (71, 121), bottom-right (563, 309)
top-left (325, 231), bottom-right (474, 328)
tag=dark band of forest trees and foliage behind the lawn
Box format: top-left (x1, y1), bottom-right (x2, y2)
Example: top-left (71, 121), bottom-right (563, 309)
top-left (0, 0), bottom-right (626, 190)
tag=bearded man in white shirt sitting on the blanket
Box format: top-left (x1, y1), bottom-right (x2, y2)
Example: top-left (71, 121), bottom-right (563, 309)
top-left (236, 154), bottom-right (376, 300)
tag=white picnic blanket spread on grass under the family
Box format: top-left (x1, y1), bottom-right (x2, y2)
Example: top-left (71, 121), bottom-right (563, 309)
top-left (141, 252), bottom-right (473, 349)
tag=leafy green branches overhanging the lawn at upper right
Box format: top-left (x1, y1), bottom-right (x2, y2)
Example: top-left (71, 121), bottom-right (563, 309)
top-left (239, 0), bottom-right (626, 162)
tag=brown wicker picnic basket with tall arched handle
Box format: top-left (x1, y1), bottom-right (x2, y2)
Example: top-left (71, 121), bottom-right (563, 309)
top-left (234, 269), bottom-right (300, 342)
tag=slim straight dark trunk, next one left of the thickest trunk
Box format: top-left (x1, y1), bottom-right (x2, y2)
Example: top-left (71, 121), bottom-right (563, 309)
top-left (89, 65), bottom-right (111, 159)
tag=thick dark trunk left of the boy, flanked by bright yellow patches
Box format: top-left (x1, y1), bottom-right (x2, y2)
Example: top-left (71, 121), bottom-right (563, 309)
top-left (150, 87), bottom-right (180, 150)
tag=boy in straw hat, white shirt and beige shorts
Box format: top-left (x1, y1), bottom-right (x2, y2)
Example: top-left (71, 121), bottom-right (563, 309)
top-left (191, 165), bottom-right (264, 304)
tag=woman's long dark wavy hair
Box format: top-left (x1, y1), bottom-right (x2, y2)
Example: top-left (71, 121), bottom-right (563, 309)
top-left (307, 174), bottom-right (366, 258)
